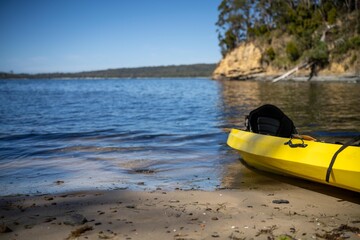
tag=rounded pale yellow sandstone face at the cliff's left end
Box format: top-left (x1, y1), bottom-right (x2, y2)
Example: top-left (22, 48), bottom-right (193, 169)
top-left (213, 43), bottom-right (264, 79)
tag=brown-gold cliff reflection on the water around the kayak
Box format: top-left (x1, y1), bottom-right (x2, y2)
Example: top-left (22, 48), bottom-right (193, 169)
top-left (221, 81), bottom-right (360, 192)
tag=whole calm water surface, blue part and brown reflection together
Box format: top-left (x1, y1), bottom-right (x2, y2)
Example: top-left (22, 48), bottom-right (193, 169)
top-left (0, 79), bottom-right (360, 195)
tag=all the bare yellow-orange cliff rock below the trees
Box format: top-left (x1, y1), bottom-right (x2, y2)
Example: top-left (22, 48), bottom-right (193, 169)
top-left (212, 42), bottom-right (360, 80)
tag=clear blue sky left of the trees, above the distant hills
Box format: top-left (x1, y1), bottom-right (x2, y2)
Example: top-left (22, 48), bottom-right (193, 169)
top-left (0, 0), bottom-right (221, 73)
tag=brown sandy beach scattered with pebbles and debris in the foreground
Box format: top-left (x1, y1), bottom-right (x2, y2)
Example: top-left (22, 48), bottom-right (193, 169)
top-left (0, 181), bottom-right (360, 240)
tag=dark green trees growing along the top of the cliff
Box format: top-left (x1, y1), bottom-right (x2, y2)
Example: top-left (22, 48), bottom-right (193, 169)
top-left (216, 0), bottom-right (360, 66)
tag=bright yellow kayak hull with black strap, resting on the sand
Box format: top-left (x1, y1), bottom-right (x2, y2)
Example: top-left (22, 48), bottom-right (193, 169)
top-left (227, 129), bottom-right (360, 192)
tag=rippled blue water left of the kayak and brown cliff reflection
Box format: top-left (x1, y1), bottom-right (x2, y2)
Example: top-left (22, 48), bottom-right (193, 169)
top-left (0, 79), bottom-right (233, 194)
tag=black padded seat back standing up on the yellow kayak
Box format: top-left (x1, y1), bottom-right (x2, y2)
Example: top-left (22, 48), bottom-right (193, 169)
top-left (245, 104), bottom-right (297, 138)
